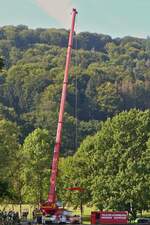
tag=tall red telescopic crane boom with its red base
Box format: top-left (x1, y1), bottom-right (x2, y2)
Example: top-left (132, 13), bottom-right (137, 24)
top-left (41, 9), bottom-right (77, 217)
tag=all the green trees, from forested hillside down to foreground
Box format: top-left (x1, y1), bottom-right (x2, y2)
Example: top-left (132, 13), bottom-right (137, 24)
top-left (0, 25), bottom-right (150, 207)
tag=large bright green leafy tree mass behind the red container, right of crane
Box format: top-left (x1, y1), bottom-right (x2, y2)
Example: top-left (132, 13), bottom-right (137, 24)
top-left (60, 110), bottom-right (150, 214)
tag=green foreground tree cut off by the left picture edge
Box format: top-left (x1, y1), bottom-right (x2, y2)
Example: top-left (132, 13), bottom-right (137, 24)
top-left (0, 119), bottom-right (20, 200)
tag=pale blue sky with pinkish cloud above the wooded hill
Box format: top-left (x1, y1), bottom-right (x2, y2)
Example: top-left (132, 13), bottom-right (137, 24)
top-left (0, 0), bottom-right (150, 38)
